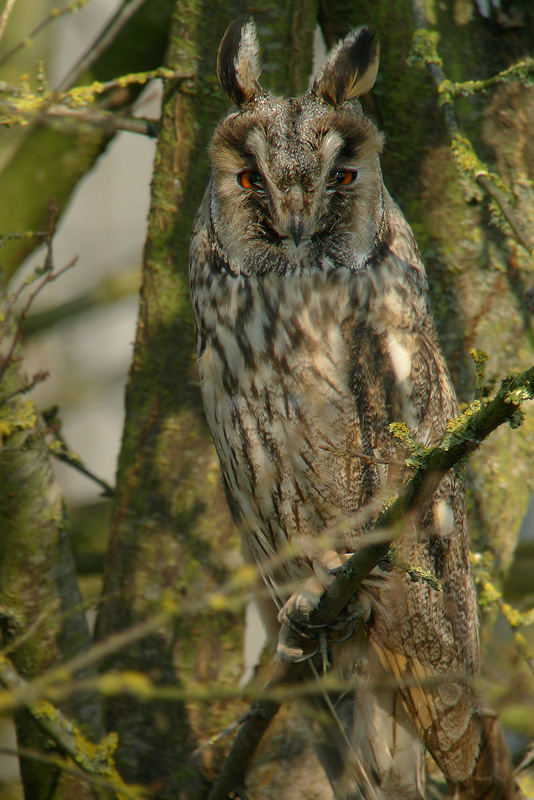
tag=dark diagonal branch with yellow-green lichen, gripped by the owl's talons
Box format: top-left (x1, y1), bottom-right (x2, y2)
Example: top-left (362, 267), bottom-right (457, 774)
top-left (209, 367), bottom-right (534, 800)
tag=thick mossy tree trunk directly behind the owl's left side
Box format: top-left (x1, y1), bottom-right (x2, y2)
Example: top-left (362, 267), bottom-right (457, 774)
top-left (92, 0), bottom-right (336, 797)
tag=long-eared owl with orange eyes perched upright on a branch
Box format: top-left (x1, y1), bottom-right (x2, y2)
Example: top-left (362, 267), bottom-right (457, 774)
top-left (190, 19), bottom-right (519, 800)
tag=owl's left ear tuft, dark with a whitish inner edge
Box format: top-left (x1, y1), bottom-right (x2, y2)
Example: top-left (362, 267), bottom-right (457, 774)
top-left (217, 16), bottom-right (261, 107)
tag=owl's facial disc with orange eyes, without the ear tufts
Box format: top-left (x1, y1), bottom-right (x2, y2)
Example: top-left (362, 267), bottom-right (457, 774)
top-left (210, 94), bottom-right (382, 274)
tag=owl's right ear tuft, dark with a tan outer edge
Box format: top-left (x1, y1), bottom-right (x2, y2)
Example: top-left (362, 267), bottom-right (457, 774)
top-left (312, 27), bottom-right (380, 108)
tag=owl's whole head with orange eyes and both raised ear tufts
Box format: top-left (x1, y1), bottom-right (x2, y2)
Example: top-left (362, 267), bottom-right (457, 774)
top-left (210, 19), bottom-right (390, 274)
